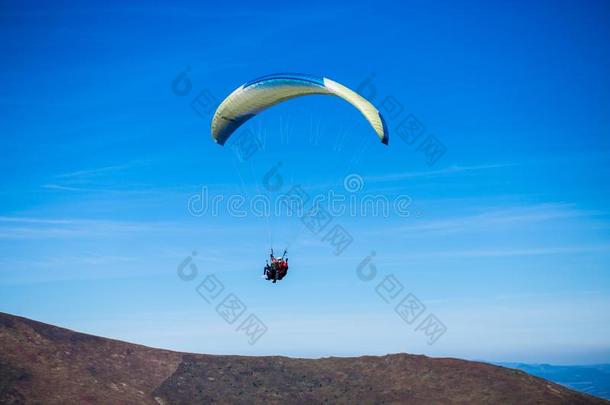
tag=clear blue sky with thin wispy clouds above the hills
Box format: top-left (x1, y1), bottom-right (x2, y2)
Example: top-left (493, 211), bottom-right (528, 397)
top-left (0, 1), bottom-right (610, 364)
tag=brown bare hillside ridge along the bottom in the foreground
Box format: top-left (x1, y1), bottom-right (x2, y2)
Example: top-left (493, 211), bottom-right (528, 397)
top-left (0, 313), bottom-right (610, 405)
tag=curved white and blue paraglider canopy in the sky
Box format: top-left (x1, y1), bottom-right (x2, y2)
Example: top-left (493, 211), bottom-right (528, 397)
top-left (211, 73), bottom-right (389, 145)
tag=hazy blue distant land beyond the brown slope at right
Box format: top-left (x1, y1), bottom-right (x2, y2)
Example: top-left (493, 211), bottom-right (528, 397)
top-left (496, 363), bottom-right (610, 400)
